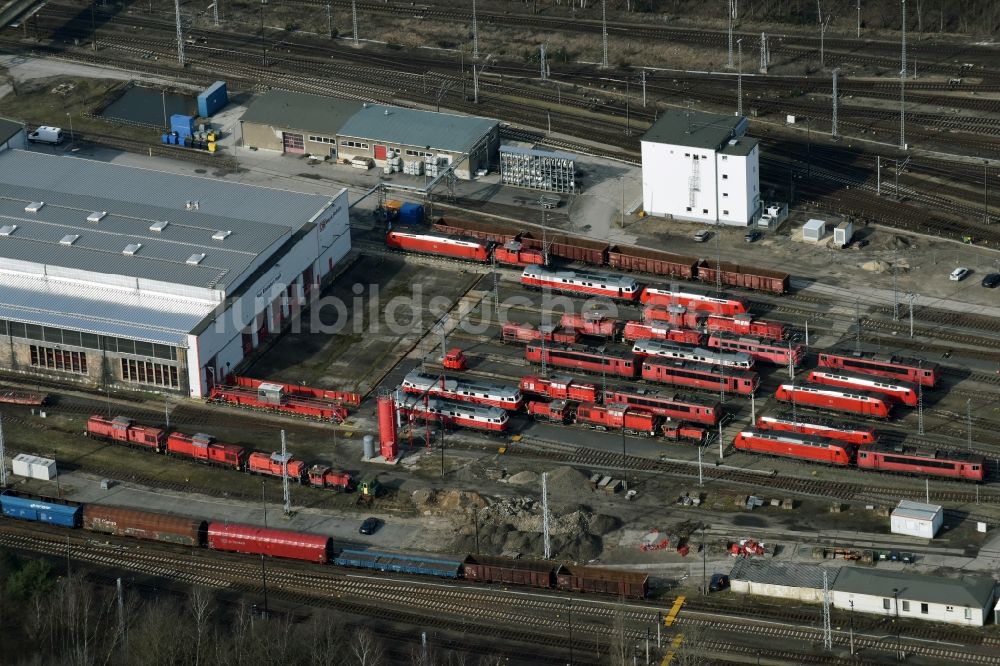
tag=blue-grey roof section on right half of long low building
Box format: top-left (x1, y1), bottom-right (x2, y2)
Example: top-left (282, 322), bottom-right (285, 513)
top-left (339, 104), bottom-right (499, 153)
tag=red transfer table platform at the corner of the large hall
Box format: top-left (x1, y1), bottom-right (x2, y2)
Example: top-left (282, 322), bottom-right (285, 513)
top-left (208, 377), bottom-right (361, 423)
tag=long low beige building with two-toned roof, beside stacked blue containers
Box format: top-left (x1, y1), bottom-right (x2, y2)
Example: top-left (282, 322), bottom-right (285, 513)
top-left (240, 90), bottom-right (500, 178)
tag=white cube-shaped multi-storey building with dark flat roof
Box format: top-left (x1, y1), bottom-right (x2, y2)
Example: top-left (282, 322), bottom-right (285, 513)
top-left (642, 110), bottom-right (761, 226)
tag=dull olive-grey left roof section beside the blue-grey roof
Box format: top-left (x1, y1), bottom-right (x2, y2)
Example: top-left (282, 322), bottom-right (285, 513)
top-left (242, 90), bottom-right (362, 136)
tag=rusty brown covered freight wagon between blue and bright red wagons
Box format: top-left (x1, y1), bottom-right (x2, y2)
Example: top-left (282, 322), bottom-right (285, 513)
top-left (83, 504), bottom-right (206, 548)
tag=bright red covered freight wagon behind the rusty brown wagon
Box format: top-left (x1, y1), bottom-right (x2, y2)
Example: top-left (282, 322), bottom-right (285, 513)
top-left (208, 523), bottom-right (333, 564)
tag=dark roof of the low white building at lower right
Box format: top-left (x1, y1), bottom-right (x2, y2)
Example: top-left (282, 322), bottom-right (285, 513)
top-left (831, 567), bottom-right (996, 608)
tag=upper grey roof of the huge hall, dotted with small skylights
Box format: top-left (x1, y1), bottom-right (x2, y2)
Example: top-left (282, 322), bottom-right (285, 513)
top-left (0, 150), bottom-right (329, 290)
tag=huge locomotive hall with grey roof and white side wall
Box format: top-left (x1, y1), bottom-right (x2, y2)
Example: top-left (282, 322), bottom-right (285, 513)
top-left (0, 150), bottom-right (350, 397)
